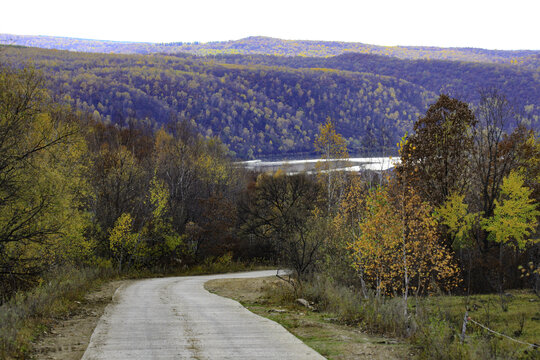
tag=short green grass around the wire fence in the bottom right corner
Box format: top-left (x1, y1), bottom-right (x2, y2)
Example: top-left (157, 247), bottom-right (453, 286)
top-left (409, 290), bottom-right (540, 359)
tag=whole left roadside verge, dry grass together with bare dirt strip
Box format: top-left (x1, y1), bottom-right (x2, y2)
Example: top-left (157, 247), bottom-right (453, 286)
top-left (0, 255), bottom-right (270, 359)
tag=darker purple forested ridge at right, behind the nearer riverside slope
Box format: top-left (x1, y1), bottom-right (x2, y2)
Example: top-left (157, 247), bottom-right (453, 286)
top-left (207, 53), bottom-right (540, 123)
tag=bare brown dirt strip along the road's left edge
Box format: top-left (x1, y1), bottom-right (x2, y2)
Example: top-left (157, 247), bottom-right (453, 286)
top-left (34, 280), bottom-right (129, 360)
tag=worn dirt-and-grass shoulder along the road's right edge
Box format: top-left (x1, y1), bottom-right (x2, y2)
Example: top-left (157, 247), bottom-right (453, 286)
top-left (205, 277), bottom-right (411, 360)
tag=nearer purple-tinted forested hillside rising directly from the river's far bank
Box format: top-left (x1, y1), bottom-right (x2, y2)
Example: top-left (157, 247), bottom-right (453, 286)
top-left (4, 47), bottom-right (435, 158)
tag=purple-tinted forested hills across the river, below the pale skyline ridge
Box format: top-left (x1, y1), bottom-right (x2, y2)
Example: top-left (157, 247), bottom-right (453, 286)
top-left (0, 46), bottom-right (540, 159)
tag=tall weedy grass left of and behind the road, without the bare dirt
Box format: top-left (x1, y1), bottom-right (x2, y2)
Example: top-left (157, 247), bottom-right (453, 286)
top-left (0, 255), bottom-right (268, 359)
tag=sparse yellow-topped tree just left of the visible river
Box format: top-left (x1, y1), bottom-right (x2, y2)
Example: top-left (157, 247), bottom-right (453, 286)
top-left (154, 121), bottom-right (240, 261)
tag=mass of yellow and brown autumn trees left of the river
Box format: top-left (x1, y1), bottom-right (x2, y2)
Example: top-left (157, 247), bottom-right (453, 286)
top-left (0, 68), bottom-right (246, 300)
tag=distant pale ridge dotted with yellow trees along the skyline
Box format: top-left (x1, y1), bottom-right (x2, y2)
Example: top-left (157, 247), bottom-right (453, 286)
top-left (0, 34), bottom-right (540, 69)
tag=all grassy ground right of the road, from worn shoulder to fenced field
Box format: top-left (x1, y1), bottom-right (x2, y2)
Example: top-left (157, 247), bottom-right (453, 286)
top-left (205, 278), bottom-right (540, 359)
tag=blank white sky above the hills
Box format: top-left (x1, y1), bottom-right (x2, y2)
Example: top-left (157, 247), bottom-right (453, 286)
top-left (0, 0), bottom-right (540, 50)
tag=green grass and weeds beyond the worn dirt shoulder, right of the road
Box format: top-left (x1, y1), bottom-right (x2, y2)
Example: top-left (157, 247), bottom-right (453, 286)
top-left (302, 277), bottom-right (540, 359)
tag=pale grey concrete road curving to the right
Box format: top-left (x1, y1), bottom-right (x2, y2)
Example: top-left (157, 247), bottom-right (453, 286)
top-left (82, 270), bottom-right (324, 360)
